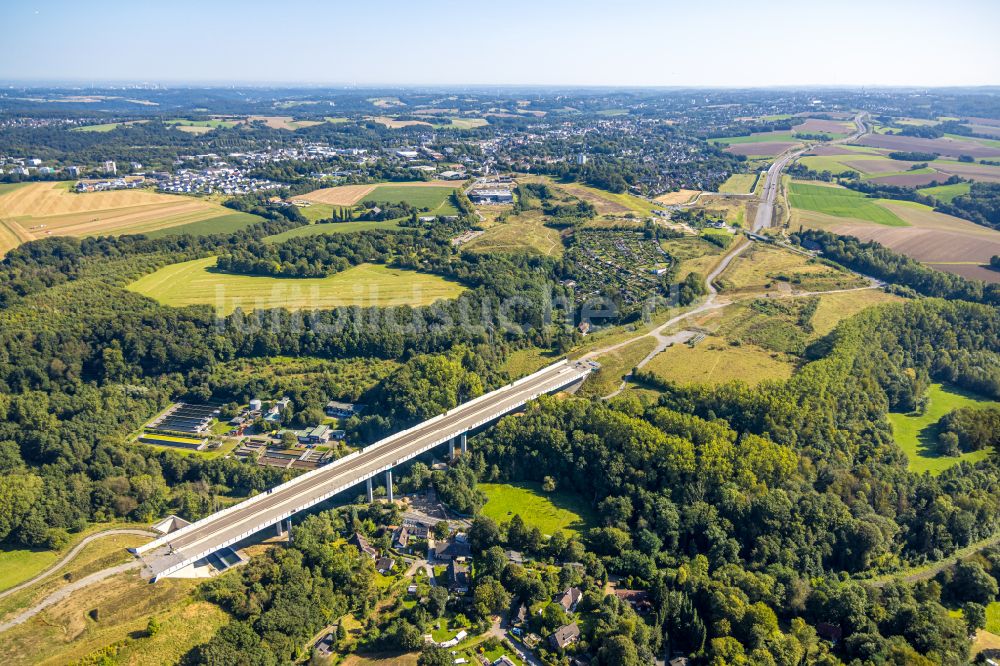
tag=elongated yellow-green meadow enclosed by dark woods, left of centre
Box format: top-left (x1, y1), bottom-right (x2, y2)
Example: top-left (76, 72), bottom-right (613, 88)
top-left (128, 257), bottom-right (465, 314)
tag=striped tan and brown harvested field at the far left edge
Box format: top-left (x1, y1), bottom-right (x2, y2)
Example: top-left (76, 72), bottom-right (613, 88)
top-left (0, 183), bottom-right (246, 253)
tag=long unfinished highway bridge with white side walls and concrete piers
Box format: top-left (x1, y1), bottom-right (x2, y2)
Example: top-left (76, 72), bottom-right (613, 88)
top-left (130, 359), bottom-right (597, 581)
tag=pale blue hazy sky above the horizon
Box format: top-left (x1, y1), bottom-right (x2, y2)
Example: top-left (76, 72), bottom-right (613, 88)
top-left (0, 0), bottom-right (1000, 86)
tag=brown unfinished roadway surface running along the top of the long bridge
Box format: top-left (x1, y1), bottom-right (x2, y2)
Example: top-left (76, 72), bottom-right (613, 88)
top-left (142, 362), bottom-right (592, 576)
